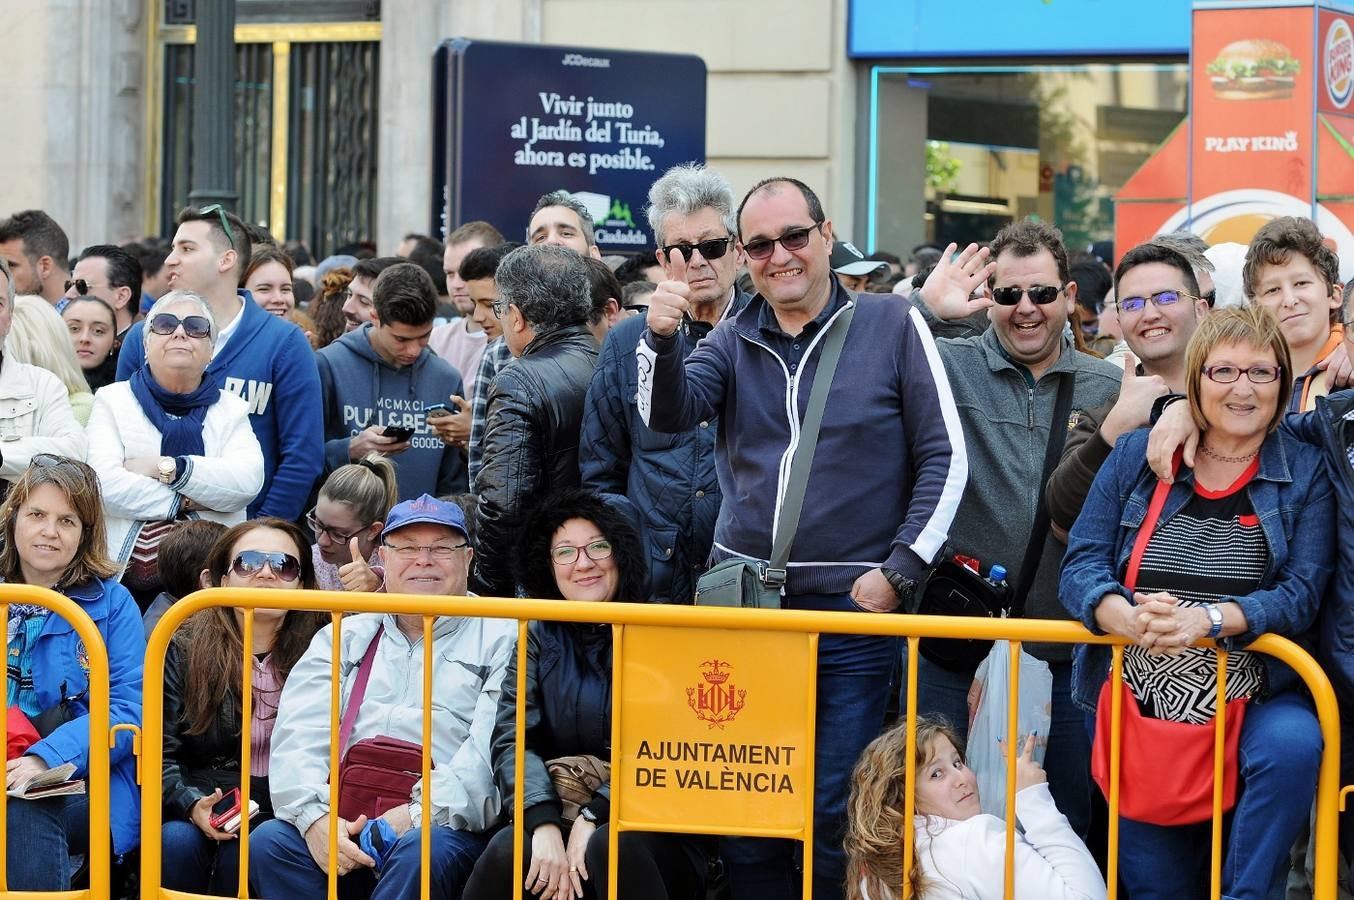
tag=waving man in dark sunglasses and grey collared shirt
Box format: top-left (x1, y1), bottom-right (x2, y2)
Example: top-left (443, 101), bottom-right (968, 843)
top-left (914, 219), bottom-right (1122, 836)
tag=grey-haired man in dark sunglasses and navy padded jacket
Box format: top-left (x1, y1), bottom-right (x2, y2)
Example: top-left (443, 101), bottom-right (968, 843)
top-left (578, 165), bottom-right (750, 604)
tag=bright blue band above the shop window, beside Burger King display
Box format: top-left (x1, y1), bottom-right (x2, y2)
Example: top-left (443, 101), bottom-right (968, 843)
top-left (848, 0), bottom-right (1190, 57)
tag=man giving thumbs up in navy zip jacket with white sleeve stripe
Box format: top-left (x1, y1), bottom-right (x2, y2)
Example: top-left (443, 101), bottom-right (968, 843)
top-left (636, 179), bottom-right (968, 900)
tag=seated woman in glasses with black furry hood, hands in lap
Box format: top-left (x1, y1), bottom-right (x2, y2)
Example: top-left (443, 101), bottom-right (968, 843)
top-left (464, 489), bottom-right (709, 900)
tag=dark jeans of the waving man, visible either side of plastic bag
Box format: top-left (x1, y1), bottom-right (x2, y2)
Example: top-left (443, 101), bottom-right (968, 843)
top-left (899, 650), bottom-right (1088, 839)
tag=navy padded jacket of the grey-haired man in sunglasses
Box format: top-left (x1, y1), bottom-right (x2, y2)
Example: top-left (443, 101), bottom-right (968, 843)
top-left (578, 291), bottom-right (750, 604)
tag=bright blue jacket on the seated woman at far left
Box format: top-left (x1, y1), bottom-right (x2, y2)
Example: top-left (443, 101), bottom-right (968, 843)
top-left (17, 579), bottom-right (146, 854)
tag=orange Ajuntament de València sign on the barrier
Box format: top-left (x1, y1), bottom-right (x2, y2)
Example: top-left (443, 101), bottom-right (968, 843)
top-left (612, 625), bottom-right (806, 836)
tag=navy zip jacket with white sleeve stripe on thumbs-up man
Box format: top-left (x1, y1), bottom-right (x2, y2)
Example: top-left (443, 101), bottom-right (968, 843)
top-left (636, 277), bottom-right (968, 594)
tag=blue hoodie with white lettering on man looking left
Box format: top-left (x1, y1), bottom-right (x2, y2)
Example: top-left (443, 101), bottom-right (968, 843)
top-left (118, 291), bottom-right (325, 521)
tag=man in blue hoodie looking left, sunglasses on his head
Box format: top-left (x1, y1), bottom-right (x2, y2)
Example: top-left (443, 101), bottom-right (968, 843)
top-left (118, 207), bottom-right (325, 521)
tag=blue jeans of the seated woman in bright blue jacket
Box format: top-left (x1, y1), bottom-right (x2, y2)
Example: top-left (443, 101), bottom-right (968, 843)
top-left (4, 794), bottom-right (89, 891)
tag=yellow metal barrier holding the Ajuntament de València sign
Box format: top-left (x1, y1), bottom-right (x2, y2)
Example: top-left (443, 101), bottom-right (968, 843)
top-left (140, 589), bottom-right (1340, 900)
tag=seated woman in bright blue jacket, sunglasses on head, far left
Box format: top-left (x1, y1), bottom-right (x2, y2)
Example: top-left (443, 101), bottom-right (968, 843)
top-left (0, 453), bottom-right (146, 891)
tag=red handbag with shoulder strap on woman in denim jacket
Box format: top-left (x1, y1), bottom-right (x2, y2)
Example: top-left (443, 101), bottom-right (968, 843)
top-left (1091, 465), bottom-right (1247, 826)
